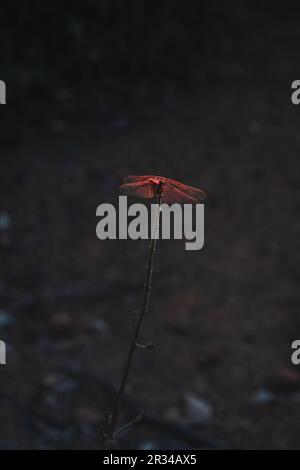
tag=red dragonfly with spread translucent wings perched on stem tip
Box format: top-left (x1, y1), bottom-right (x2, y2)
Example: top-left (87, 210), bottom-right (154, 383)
top-left (119, 175), bottom-right (206, 204)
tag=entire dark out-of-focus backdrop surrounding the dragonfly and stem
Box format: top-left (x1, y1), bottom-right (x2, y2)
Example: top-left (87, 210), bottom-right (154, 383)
top-left (0, 0), bottom-right (300, 449)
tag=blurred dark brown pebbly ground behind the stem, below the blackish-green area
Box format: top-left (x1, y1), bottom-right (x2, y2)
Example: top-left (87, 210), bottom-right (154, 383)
top-left (0, 15), bottom-right (300, 449)
